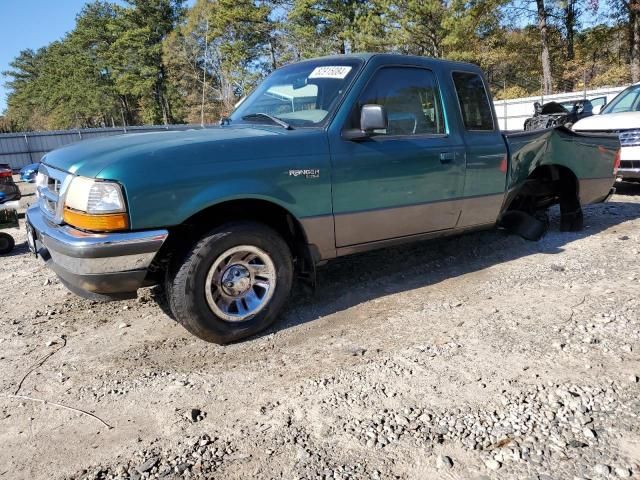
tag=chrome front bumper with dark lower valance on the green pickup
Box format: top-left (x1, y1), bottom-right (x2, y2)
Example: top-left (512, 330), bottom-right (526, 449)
top-left (26, 205), bottom-right (169, 295)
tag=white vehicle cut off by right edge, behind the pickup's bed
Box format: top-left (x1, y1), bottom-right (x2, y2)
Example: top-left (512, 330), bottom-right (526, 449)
top-left (573, 83), bottom-right (640, 181)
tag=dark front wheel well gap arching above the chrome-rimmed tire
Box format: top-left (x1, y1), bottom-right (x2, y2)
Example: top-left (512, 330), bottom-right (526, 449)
top-left (146, 199), bottom-right (315, 281)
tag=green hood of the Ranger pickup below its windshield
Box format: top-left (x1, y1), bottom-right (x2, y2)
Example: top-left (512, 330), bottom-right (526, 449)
top-left (43, 125), bottom-right (308, 180)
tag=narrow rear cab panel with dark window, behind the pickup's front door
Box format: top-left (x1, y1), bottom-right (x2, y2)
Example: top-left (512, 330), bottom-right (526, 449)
top-left (451, 71), bottom-right (509, 228)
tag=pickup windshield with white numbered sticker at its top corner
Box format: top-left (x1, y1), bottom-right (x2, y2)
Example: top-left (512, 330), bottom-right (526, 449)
top-left (229, 58), bottom-right (363, 128)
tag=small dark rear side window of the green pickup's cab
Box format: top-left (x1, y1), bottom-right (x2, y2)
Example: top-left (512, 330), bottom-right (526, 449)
top-left (453, 72), bottom-right (494, 130)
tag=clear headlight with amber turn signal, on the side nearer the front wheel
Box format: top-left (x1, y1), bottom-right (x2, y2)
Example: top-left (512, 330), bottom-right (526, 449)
top-left (64, 177), bottom-right (129, 232)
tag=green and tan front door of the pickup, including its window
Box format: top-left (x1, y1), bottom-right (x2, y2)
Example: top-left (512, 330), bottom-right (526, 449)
top-left (330, 66), bottom-right (465, 247)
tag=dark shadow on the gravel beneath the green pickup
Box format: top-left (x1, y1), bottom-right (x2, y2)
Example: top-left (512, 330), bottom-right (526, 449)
top-left (259, 183), bottom-right (640, 335)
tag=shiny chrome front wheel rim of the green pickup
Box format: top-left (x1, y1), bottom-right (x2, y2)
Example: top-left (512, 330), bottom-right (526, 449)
top-left (205, 245), bottom-right (276, 322)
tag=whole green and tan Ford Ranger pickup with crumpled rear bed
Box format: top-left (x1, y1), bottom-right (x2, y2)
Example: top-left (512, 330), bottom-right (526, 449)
top-left (27, 54), bottom-right (620, 343)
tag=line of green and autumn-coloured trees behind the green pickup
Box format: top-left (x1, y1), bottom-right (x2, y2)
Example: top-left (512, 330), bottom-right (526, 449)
top-left (0, 0), bottom-right (640, 131)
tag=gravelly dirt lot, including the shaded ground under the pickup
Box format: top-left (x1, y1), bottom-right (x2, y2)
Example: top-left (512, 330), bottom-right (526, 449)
top-left (0, 181), bottom-right (640, 480)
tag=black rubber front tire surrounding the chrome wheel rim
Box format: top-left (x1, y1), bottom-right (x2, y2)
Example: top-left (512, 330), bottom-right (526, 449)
top-left (165, 222), bottom-right (293, 344)
